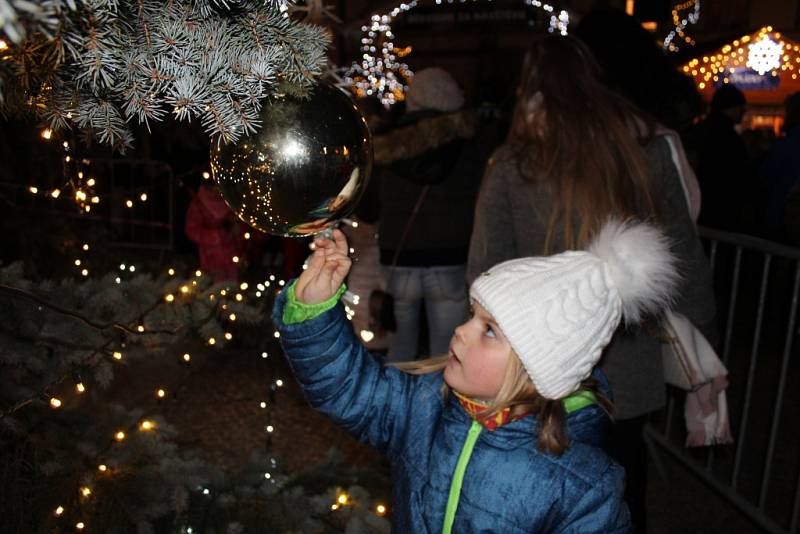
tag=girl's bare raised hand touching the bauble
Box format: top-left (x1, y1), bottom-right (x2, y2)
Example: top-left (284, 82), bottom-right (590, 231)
top-left (294, 229), bottom-right (352, 304)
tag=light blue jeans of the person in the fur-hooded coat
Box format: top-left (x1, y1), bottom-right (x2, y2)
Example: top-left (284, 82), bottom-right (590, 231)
top-left (384, 265), bottom-right (469, 362)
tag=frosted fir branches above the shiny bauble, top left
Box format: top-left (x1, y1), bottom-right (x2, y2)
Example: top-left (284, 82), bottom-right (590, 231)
top-left (0, 0), bottom-right (330, 151)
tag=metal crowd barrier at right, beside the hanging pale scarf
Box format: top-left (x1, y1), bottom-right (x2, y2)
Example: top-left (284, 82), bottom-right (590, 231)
top-left (645, 228), bottom-right (800, 534)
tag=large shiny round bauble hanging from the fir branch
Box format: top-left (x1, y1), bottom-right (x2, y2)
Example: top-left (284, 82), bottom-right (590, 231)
top-left (211, 83), bottom-right (372, 236)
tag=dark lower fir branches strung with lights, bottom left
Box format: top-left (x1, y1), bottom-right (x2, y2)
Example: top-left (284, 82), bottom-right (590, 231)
top-left (0, 263), bottom-right (389, 533)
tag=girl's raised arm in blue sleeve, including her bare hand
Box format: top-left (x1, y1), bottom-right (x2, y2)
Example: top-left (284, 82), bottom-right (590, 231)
top-left (272, 233), bottom-right (442, 455)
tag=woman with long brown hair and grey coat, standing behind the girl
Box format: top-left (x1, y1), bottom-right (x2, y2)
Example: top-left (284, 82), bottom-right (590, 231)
top-left (467, 35), bottom-right (715, 532)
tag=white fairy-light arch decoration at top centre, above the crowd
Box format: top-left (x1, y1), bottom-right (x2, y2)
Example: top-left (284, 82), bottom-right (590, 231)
top-left (344, 0), bottom-right (569, 108)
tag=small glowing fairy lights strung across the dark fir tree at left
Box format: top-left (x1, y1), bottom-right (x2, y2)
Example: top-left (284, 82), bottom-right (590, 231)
top-left (13, 130), bottom-right (387, 532)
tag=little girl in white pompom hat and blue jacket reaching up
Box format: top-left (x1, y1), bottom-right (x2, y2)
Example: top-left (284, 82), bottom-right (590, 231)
top-left (273, 221), bottom-right (677, 534)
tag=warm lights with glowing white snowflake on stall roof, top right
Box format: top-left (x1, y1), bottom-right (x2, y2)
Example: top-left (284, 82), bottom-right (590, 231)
top-left (682, 26), bottom-right (800, 90)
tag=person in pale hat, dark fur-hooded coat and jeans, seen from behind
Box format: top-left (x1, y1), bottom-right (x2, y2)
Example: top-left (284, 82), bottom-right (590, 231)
top-left (373, 68), bottom-right (491, 361)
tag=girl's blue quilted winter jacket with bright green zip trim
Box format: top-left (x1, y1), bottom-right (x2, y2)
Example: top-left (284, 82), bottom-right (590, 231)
top-left (272, 290), bottom-right (631, 534)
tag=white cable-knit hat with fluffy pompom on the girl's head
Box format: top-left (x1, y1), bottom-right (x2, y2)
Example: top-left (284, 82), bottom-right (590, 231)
top-left (470, 219), bottom-right (679, 399)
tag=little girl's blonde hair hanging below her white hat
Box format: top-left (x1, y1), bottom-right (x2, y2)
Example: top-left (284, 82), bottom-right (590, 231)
top-left (389, 350), bottom-right (613, 455)
